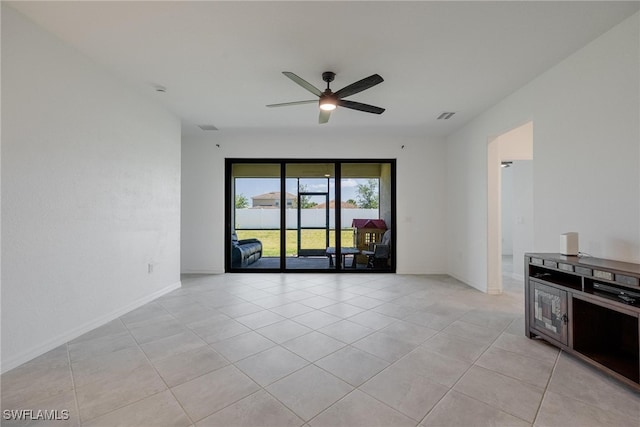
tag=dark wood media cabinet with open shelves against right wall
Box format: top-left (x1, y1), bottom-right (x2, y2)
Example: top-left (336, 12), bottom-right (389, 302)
top-left (525, 253), bottom-right (640, 389)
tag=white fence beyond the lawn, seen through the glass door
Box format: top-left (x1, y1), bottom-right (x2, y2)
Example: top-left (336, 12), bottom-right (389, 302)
top-left (235, 208), bottom-right (379, 230)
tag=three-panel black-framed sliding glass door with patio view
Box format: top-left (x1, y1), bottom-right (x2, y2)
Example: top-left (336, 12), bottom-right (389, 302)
top-left (225, 159), bottom-right (395, 272)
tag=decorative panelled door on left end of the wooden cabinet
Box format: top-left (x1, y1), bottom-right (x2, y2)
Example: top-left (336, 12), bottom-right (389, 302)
top-left (529, 280), bottom-right (568, 345)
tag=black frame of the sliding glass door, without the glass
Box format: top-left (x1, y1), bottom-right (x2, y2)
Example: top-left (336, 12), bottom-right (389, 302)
top-left (224, 158), bottom-right (397, 273)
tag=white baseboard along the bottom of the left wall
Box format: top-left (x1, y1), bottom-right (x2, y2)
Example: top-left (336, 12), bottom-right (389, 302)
top-left (0, 281), bottom-right (182, 374)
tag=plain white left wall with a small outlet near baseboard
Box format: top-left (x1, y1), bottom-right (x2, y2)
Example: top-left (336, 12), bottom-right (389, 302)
top-left (1, 4), bottom-right (180, 371)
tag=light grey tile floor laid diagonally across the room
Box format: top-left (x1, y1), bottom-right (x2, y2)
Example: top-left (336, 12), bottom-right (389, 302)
top-left (1, 274), bottom-right (640, 427)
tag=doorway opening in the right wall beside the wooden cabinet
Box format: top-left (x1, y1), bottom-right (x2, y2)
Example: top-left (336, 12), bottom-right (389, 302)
top-left (487, 122), bottom-right (533, 294)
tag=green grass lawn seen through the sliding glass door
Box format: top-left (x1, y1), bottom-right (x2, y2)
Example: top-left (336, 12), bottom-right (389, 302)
top-left (236, 228), bottom-right (353, 256)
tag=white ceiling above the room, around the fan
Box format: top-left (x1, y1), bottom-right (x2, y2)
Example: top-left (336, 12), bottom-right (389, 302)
top-left (10, 1), bottom-right (640, 135)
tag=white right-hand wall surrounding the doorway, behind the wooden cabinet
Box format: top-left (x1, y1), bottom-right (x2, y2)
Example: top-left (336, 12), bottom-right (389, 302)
top-left (447, 14), bottom-right (640, 290)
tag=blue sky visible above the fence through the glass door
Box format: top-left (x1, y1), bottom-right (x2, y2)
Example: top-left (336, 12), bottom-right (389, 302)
top-left (236, 178), bottom-right (376, 204)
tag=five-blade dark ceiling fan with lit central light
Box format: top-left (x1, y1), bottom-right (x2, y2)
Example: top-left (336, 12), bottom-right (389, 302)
top-left (267, 71), bottom-right (384, 124)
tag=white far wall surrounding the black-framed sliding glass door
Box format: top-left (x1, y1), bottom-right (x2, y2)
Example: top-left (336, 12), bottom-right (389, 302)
top-left (182, 130), bottom-right (446, 273)
